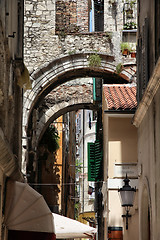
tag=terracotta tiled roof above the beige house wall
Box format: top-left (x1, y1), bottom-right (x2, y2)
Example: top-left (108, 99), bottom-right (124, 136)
top-left (103, 84), bottom-right (137, 110)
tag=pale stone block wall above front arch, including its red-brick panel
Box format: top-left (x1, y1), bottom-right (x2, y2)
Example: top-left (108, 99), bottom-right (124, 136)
top-left (24, 0), bottom-right (111, 72)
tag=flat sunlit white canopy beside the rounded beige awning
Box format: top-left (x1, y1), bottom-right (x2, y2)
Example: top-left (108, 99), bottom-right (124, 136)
top-left (53, 213), bottom-right (97, 239)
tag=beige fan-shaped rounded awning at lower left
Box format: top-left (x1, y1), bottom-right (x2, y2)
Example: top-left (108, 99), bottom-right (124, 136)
top-left (5, 181), bottom-right (55, 233)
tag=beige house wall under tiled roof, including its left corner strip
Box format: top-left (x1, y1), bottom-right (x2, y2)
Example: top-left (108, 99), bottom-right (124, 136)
top-left (103, 93), bottom-right (139, 240)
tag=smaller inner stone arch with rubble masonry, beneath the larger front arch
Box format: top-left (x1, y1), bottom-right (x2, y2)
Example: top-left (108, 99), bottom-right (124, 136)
top-left (36, 79), bottom-right (96, 144)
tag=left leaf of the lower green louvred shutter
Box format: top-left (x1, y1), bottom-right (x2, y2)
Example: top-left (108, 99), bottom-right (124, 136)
top-left (88, 142), bottom-right (95, 181)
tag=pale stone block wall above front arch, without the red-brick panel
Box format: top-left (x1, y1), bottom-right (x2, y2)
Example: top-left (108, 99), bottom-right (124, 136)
top-left (24, 4), bottom-right (113, 72)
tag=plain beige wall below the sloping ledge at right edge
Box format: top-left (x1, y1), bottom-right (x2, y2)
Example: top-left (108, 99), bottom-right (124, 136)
top-left (138, 88), bottom-right (160, 240)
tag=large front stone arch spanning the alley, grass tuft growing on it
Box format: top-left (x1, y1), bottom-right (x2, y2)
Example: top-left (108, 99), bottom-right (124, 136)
top-left (23, 52), bottom-right (135, 137)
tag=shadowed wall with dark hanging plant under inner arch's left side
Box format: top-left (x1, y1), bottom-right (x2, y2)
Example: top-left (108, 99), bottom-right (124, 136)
top-left (27, 127), bottom-right (61, 213)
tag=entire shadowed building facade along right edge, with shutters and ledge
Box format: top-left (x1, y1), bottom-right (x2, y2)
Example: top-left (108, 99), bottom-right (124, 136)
top-left (133, 0), bottom-right (160, 240)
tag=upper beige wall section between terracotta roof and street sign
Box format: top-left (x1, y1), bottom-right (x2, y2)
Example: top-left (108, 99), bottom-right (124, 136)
top-left (108, 115), bottom-right (137, 178)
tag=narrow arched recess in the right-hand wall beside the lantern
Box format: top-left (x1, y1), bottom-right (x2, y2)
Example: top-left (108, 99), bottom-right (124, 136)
top-left (140, 178), bottom-right (152, 240)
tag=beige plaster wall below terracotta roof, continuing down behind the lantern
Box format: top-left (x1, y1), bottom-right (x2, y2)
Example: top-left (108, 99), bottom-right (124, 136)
top-left (108, 115), bottom-right (138, 240)
